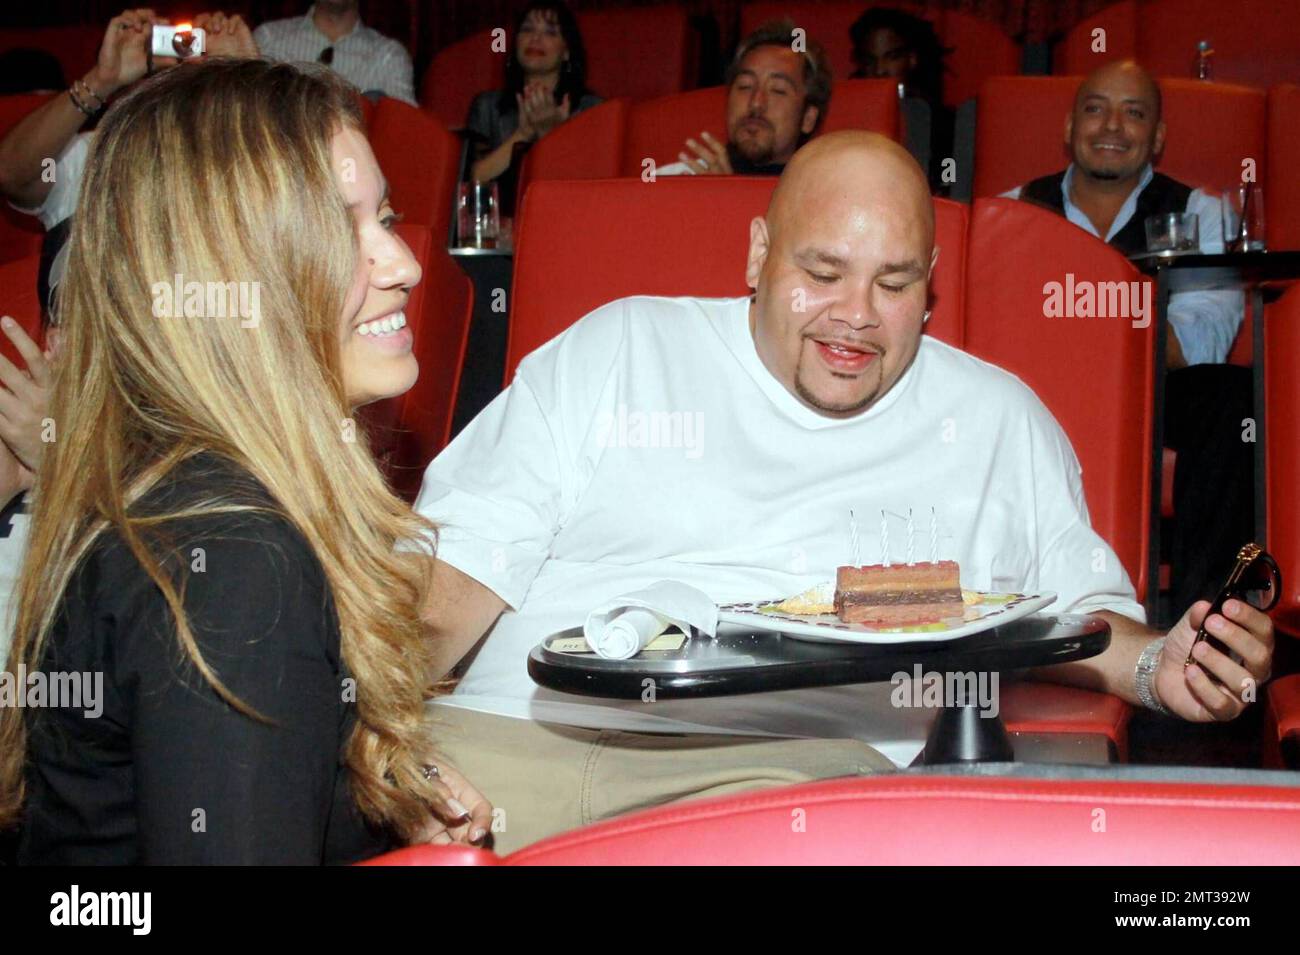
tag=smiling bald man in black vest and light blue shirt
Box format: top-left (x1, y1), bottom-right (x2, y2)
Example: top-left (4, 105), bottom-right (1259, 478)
top-left (1005, 61), bottom-right (1255, 622)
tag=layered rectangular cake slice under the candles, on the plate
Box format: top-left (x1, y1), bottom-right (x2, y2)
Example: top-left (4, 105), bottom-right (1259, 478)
top-left (835, 560), bottom-right (965, 626)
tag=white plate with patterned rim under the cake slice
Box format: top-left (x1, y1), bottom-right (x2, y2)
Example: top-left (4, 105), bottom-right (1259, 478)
top-left (718, 591), bottom-right (1056, 643)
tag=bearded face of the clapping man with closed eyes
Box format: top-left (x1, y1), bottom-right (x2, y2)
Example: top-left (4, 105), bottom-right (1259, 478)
top-left (727, 45), bottom-right (818, 165)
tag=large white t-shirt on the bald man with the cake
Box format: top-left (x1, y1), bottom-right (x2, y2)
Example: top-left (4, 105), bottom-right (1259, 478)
top-left (416, 298), bottom-right (1144, 764)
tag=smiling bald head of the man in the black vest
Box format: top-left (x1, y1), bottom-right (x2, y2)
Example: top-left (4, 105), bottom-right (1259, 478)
top-left (1065, 62), bottom-right (1165, 183)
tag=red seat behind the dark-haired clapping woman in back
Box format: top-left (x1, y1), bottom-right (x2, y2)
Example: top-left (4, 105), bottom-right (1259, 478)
top-left (420, 4), bottom-right (699, 129)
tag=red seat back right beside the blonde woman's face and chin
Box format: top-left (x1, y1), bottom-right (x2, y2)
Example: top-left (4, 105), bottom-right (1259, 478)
top-left (364, 222), bottom-right (473, 500)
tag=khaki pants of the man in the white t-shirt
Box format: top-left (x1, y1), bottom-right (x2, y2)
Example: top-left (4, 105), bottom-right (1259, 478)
top-left (434, 706), bottom-right (893, 854)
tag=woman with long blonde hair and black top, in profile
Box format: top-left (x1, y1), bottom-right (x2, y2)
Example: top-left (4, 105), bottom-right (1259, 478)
top-left (0, 60), bottom-right (491, 864)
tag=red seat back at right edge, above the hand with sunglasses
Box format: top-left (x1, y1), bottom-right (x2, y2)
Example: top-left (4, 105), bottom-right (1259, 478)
top-left (1264, 286), bottom-right (1300, 637)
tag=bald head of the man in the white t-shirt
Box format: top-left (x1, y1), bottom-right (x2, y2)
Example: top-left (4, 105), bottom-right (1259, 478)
top-left (746, 131), bottom-right (937, 417)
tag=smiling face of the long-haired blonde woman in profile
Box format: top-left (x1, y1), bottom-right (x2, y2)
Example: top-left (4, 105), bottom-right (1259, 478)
top-left (332, 127), bottom-right (420, 408)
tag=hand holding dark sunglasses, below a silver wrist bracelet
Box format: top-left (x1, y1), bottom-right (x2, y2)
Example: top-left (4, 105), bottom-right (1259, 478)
top-left (1152, 599), bottom-right (1273, 722)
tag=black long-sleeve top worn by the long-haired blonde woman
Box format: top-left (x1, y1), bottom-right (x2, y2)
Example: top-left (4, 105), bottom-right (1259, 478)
top-left (18, 455), bottom-right (391, 864)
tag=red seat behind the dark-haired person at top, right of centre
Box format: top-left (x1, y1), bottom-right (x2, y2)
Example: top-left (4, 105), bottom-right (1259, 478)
top-left (740, 0), bottom-right (1021, 107)
